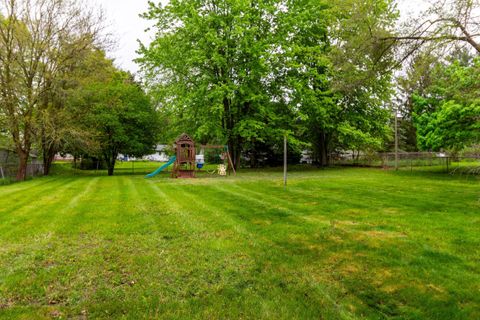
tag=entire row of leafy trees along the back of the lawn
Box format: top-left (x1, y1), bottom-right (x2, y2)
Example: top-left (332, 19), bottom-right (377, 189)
top-left (0, 0), bottom-right (480, 179)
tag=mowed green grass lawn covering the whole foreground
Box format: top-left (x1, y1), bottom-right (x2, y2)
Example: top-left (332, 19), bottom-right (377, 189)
top-left (0, 168), bottom-right (480, 319)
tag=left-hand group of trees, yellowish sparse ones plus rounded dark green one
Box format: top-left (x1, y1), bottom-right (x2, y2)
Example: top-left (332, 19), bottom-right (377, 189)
top-left (0, 0), bottom-right (157, 180)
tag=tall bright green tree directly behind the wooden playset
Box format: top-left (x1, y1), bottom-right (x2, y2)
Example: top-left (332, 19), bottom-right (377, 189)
top-left (139, 0), bottom-right (279, 166)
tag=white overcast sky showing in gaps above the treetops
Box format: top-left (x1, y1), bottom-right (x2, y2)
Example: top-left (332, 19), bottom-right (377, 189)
top-left (89, 0), bottom-right (425, 72)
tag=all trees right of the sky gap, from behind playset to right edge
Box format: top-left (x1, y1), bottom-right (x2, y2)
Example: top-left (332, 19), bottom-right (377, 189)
top-left (138, 0), bottom-right (480, 166)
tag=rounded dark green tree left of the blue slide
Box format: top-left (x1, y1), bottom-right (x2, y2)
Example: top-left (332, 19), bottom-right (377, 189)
top-left (71, 71), bottom-right (159, 175)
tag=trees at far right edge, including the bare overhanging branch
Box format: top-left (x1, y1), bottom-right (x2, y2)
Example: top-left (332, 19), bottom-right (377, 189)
top-left (392, 0), bottom-right (480, 155)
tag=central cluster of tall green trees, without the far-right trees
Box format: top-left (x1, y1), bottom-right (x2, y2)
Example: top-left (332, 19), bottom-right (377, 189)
top-left (138, 0), bottom-right (396, 165)
